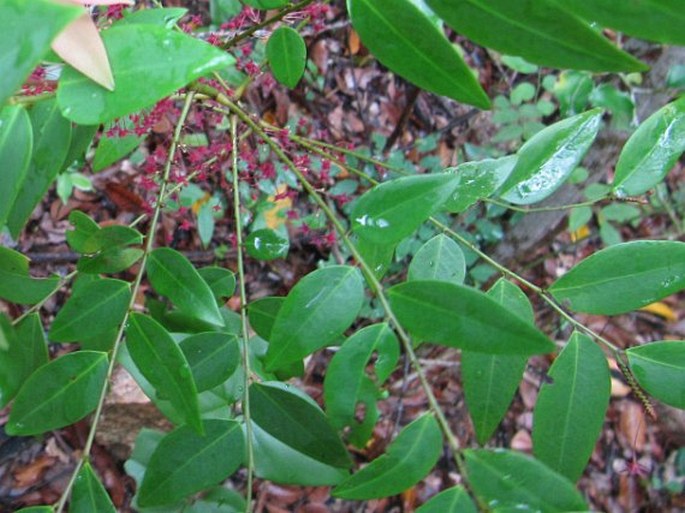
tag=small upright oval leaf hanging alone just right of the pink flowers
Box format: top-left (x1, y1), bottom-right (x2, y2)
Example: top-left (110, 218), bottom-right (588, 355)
top-left (266, 26), bottom-right (307, 89)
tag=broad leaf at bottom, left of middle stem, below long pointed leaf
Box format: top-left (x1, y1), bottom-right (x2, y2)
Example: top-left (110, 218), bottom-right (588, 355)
top-left (138, 420), bottom-right (245, 506)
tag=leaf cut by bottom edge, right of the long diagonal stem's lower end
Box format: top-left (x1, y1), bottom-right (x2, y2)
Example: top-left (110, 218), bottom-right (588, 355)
top-left (464, 449), bottom-right (588, 513)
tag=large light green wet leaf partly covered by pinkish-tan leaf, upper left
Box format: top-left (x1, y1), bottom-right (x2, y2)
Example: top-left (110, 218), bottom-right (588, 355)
top-left (57, 24), bottom-right (235, 125)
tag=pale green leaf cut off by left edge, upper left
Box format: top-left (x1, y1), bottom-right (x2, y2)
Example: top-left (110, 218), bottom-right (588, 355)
top-left (0, 106), bottom-right (33, 227)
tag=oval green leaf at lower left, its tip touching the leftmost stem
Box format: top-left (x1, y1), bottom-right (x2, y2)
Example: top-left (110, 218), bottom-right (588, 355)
top-left (5, 351), bottom-right (107, 436)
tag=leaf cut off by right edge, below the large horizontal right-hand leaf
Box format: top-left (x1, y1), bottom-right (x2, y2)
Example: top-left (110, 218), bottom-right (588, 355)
top-left (626, 340), bottom-right (685, 409)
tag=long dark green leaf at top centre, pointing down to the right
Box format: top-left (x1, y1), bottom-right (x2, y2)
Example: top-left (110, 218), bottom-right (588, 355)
top-left (347, 0), bottom-right (490, 109)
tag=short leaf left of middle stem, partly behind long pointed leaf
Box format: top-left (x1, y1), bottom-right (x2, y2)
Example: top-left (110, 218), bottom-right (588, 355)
top-left (179, 332), bottom-right (240, 392)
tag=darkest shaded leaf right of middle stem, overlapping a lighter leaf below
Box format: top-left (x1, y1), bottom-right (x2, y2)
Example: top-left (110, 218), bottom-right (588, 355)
top-left (249, 383), bottom-right (351, 467)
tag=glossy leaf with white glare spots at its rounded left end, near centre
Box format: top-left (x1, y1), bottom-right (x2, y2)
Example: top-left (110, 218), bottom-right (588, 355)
top-left (350, 173), bottom-right (459, 245)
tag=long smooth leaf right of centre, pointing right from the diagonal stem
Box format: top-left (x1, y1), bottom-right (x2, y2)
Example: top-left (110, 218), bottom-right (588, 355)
top-left (388, 281), bottom-right (554, 356)
